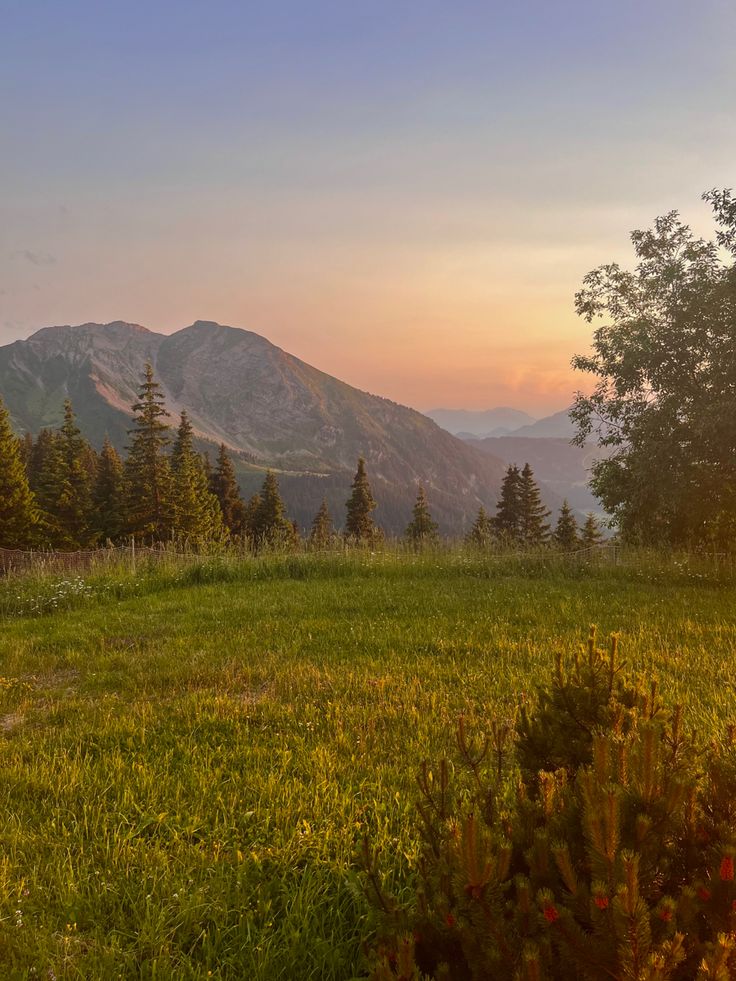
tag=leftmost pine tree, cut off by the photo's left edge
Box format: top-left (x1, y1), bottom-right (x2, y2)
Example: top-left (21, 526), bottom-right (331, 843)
top-left (0, 399), bottom-right (39, 549)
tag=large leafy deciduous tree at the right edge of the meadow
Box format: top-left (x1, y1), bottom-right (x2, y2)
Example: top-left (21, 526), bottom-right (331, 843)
top-left (571, 190), bottom-right (736, 548)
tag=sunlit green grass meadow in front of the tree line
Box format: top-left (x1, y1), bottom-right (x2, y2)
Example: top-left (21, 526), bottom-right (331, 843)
top-left (0, 552), bottom-right (736, 981)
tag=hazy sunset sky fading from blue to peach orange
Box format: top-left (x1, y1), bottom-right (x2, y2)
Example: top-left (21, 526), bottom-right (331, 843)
top-left (0, 0), bottom-right (736, 416)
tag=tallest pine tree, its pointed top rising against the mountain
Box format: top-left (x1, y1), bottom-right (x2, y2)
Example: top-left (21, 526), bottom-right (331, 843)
top-left (125, 363), bottom-right (171, 541)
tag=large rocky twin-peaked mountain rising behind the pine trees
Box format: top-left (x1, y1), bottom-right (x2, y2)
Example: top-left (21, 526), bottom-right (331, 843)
top-left (0, 321), bottom-right (559, 534)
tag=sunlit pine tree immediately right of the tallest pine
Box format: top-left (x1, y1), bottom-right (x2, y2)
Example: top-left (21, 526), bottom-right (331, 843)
top-left (171, 410), bottom-right (223, 545)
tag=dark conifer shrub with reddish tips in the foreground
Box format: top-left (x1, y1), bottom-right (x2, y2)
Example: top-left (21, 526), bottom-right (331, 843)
top-left (364, 629), bottom-right (736, 981)
